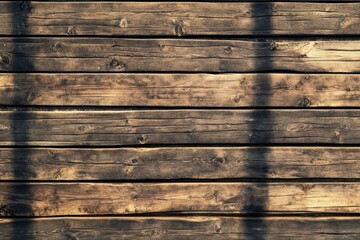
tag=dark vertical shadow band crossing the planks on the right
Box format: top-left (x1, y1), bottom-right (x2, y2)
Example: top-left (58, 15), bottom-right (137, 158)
top-left (243, 3), bottom-right (275, 240)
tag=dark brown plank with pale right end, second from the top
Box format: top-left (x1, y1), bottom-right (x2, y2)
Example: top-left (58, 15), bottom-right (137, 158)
top-left (0, 38), bottom-right (360, 72)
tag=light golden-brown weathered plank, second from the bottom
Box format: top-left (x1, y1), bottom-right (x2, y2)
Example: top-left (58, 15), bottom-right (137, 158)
top-left (0, 182), bottom-right (360, 216)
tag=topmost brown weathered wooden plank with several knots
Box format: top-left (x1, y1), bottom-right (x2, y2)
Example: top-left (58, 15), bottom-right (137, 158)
top-left (0, 1), bottom-right (360, 36)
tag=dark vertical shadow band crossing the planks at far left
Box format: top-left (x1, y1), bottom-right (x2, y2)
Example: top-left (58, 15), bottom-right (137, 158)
top-left (8, 1), bottom-right (34, 240)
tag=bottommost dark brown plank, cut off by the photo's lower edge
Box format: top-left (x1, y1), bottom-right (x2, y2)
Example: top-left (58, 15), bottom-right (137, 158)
top-left (0, 217), bottom-right (360, 240)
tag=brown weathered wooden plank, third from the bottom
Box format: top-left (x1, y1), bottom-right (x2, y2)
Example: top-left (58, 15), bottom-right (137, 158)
top-left (0, 147), bottom-right (360, 181)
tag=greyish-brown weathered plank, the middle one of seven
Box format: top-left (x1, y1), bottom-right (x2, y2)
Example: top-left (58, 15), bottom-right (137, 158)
top-left (0, 109), bottom-right (360, 146)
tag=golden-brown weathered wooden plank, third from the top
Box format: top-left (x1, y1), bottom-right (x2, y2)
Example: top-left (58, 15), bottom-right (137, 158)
top-left (0, 73), bottom-right (360, 107)
